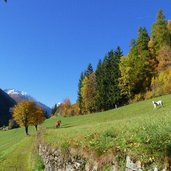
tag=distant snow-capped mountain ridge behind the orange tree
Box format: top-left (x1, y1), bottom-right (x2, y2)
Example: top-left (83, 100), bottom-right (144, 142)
top-left (4, 89), bottom-right (51, 117)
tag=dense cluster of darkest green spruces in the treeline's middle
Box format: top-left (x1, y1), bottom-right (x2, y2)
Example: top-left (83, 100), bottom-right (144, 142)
top-left (96, 48), bottom-right (122, 110)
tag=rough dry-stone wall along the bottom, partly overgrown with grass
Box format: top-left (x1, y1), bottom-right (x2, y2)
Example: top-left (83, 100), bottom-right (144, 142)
top-left (39, 144), bottom-right (166, 171)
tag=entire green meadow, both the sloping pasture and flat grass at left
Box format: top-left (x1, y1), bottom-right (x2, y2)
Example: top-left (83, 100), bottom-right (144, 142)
top-left (0, 95), bottom-right (171, 171)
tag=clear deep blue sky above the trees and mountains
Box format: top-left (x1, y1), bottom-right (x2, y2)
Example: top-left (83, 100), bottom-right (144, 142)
top-left (0, 0), bottom-right (171, 107)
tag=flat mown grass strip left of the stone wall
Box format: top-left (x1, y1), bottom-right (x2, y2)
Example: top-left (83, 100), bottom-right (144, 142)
top-left (0, 128), bottom-right (35, 171)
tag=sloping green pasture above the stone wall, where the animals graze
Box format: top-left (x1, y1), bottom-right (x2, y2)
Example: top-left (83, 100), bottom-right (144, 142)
top-left (44, 95), bottom-right (171, 168)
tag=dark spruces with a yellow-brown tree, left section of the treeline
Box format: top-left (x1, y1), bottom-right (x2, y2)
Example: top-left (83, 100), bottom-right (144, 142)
top-left (78, 47), bottom-right (123, 114)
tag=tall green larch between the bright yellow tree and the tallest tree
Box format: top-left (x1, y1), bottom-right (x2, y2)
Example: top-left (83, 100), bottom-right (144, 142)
top-left (134, 27), bottom-right (157, 93)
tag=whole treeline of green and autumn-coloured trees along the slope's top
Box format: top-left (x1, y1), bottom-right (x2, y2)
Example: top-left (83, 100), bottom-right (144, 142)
top-left (53, 10), bottom-right (171, 116)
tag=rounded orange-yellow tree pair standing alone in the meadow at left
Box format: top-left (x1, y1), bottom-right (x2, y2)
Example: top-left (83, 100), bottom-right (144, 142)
top-left (13, 100), bottom-right (44, 135)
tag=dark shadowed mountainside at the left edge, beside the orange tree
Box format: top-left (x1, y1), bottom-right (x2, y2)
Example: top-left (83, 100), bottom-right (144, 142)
top-left (0, 89), bottom-right (16, 127)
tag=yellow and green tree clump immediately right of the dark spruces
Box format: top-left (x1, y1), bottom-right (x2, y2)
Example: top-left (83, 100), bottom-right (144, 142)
top-left (119, 27), bottom-right (157, 100)
